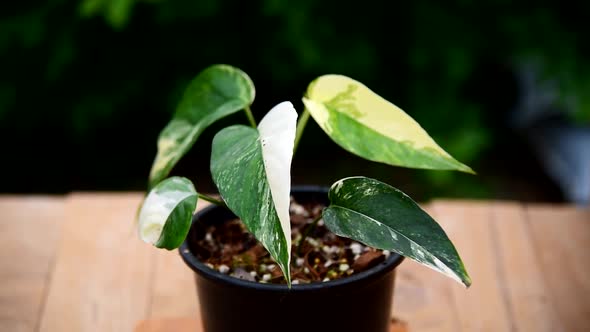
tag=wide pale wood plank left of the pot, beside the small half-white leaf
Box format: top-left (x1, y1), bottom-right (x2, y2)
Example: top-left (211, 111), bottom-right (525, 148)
top-left (40, 194), bottom-right (154, 332)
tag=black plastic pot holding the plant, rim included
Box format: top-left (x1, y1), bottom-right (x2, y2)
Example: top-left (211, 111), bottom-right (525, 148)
top-left (180, 187), bottom-right (403, 332)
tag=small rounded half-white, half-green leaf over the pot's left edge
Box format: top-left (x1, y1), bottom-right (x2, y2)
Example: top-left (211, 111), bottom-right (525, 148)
top-left (139, 177), bottom-right (197, 250)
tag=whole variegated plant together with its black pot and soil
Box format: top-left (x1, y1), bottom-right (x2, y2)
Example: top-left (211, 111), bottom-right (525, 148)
top-left (139, 65), bottom-right (473, 332)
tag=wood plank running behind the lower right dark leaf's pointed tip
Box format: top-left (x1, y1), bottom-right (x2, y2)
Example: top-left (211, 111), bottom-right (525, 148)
top-left (433, 201), bottom-right (514, 331)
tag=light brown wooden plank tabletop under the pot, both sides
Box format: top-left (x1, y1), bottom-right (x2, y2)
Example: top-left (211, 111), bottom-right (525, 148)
top-left (0, 193), bottom-right (590, 332)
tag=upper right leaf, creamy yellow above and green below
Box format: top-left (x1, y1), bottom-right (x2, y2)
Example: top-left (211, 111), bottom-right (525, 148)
top-left (303, 75), bottom-right (473, 173)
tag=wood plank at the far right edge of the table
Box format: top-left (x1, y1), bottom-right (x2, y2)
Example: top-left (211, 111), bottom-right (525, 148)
top-left (526, 205), bottom-right (590, 331)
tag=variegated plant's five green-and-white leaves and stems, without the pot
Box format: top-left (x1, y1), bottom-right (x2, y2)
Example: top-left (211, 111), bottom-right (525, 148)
top-left (139, 65), bottom-right (473, 287)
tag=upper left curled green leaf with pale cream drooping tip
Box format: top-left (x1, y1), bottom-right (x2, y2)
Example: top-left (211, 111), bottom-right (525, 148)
top-left (149, 65), bottom-right (254, 188)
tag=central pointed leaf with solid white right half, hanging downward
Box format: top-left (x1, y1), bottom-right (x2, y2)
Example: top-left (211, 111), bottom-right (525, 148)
top-left (211, 102), bottom-right (297, 285)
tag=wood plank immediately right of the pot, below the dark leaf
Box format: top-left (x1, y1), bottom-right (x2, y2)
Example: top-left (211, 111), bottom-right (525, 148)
top-left (392, 205), bottom-right (459, 332)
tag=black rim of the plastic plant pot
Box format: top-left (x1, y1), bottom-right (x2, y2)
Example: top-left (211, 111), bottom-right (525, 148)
top-left (178, 201), bottom-right (404, 293)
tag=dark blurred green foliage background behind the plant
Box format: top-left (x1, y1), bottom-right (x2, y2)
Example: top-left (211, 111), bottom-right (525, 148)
top-left (0, 0), bottom-right (590, 201)
